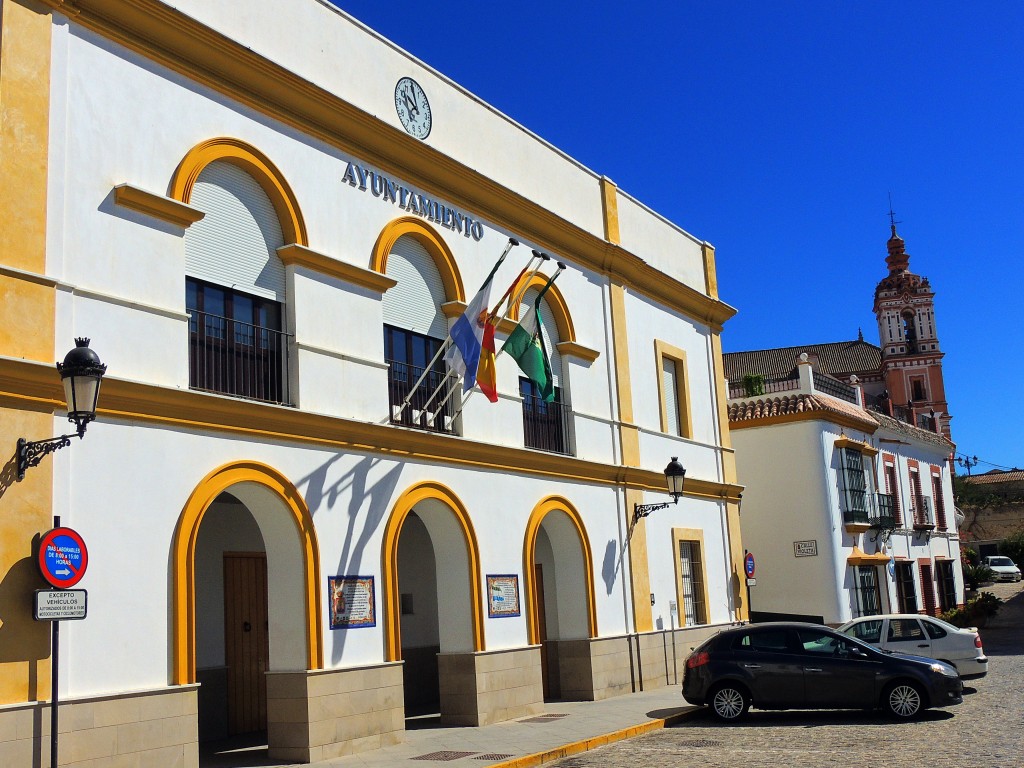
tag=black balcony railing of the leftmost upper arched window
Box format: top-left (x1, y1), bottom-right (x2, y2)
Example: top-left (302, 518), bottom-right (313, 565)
top-left (188, 309), bottom-right (289, 403)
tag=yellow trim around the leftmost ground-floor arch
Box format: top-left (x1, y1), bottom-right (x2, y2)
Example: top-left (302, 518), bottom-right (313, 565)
top-left (171, 462), bottom-right (324, 685)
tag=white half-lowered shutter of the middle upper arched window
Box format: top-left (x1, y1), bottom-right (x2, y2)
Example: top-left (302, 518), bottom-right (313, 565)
top-left (383, 236), bottom-right (447, 339)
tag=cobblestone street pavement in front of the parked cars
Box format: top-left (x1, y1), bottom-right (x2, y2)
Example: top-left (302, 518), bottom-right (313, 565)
top-left (549, 584), bottom-right (1024, 768)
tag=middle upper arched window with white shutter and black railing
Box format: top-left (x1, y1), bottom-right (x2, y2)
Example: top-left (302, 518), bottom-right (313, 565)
top-left (383, 234), bottom-right (458, 432)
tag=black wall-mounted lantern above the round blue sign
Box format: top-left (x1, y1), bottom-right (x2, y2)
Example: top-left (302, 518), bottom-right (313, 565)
top-left (17, 339), bottom-right (106, 480)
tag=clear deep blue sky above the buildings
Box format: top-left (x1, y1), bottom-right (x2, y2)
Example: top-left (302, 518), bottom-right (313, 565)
top-left (336, 0), bottom-right (1024, 473)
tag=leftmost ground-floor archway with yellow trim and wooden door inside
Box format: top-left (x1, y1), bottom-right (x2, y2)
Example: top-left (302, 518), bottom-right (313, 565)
top-left (171, 462), bottom-right (323, 749)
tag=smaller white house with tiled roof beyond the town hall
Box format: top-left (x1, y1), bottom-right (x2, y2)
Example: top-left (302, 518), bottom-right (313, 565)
top-left (729, 355), bottom-right (964, 626)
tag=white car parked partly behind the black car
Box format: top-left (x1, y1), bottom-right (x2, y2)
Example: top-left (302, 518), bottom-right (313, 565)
top-left (839, 613), bottom-right (988, 680)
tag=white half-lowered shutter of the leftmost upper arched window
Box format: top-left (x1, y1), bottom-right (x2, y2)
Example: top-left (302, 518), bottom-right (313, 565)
top-left (185, 161), bottom-right (286, 302)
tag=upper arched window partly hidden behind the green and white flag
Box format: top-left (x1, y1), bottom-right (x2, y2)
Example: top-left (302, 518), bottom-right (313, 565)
top-left (519, 287), bottom-right (571, 454)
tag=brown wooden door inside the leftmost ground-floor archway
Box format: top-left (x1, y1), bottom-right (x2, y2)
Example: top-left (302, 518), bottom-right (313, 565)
top-left (224, 552), bottom-right (270, 735)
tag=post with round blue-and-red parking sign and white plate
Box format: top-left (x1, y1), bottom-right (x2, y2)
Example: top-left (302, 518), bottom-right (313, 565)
top-left (35, 528), bottom-right (89, 768)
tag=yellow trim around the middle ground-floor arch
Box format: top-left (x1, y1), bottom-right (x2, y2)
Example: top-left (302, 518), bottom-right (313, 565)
top-left (381, 480), bottom-right (484, 662)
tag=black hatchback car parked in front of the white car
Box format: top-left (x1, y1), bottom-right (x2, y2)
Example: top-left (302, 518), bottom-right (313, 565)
top-left (683, 623), bottom-right (964, 721)
